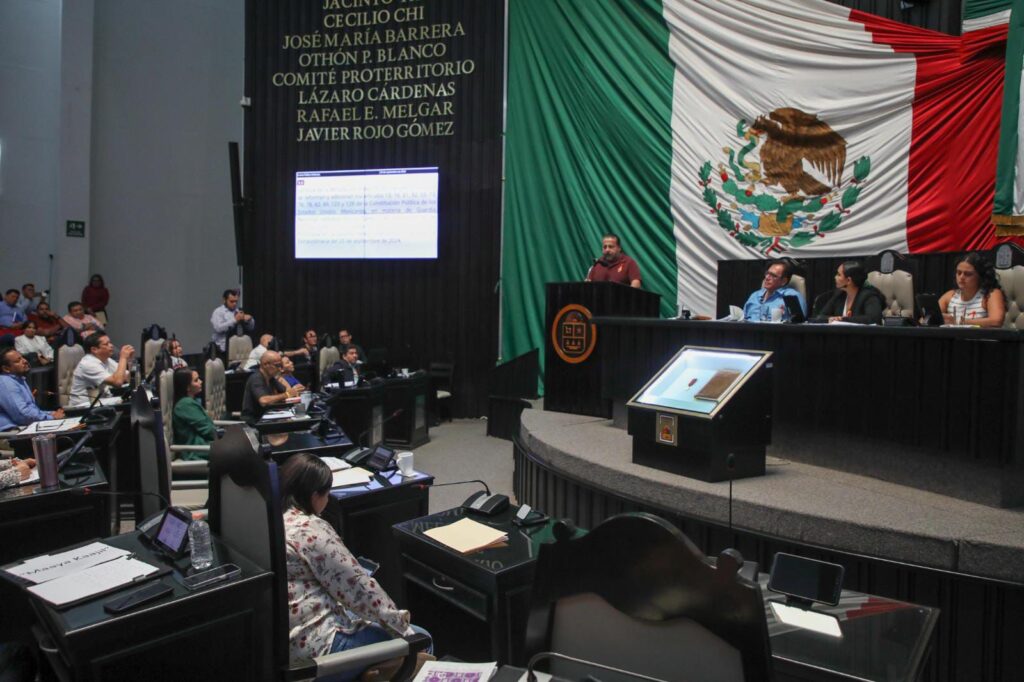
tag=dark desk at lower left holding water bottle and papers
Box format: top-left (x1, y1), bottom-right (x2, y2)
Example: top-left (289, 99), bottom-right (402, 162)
top-left (22, 532), bottom-right (274, 682)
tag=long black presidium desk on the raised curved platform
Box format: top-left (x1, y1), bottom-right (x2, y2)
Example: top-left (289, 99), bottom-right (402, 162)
top-left (594, 317), bottom-right (1024, 507)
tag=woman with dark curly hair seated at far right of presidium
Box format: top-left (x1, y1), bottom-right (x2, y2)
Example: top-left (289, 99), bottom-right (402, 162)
top-left (939, 253), bottom-right (1007, 328)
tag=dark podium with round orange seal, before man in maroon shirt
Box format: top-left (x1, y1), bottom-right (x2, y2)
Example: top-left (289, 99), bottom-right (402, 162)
top-left (544, 282), bottom-right (662, 418)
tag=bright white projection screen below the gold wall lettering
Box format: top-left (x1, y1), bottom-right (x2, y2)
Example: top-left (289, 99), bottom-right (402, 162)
top-left (295, 167), bottom-right (438, 259)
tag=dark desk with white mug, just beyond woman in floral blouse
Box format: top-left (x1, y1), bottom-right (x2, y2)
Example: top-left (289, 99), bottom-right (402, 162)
top-left (322, 464), bottom-right (434, 602)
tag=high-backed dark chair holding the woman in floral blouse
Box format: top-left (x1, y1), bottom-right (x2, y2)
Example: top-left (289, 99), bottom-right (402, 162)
top-left (209, 426), bottom-right (429, 680)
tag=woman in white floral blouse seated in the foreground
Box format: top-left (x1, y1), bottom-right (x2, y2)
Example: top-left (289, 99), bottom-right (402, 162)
top-left (281, 453), bottom-right (429, 680)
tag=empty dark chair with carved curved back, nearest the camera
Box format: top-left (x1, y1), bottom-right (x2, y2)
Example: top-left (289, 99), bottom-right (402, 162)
top-left (524, 513), bottom-right (771, 682)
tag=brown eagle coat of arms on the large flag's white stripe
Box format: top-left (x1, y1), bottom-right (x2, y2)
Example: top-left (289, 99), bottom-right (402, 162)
top-left (698, 106), bottom-right (871, 256)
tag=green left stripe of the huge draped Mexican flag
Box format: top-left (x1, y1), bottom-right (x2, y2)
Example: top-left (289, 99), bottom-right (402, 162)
top-left (502, 0), bottom-right (677, 387)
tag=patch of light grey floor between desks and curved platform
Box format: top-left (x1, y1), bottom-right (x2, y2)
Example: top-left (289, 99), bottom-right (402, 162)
top-left (414, 419), bottom-right (514, 514)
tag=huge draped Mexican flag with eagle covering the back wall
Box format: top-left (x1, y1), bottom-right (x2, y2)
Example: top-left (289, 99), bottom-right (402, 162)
top-left (503, 0), bottom-right (1007, 357)
